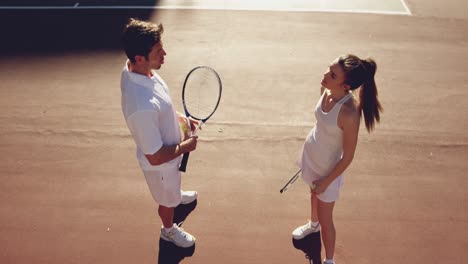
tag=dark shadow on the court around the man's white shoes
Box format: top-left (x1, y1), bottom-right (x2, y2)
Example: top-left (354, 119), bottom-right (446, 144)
top-left (158, 200), bottom-right (197, 264)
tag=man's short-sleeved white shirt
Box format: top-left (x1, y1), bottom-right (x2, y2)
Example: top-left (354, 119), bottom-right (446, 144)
top-left (121, 61), bottom-right (181, 171)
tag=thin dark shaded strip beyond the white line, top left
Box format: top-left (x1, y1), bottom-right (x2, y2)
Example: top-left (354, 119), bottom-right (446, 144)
top-left (0, 0), bottom-right (159, 8)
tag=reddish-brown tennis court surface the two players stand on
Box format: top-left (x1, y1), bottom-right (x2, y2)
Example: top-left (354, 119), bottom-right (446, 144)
top-left (0, 0), bottom-right (468, 264)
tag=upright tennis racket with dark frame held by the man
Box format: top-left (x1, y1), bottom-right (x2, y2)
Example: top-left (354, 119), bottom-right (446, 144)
top-left (179, 66), bottom-right (222, 172)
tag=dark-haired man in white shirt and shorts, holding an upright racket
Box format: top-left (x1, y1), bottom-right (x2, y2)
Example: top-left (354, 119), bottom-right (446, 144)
top-left (121, 19), bottom-right (198, 247)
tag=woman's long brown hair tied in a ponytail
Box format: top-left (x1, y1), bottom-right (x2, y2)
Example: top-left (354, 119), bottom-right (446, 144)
top-left (338, 54), bottom-right (383, 132)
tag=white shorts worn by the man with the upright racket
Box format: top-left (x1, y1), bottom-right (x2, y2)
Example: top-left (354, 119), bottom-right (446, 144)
top-left (143, 167), bottom-right (182, 208)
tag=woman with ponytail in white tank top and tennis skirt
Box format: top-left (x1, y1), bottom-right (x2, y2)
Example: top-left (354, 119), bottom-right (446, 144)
top-left (292, 55), bottom-right (382, 264)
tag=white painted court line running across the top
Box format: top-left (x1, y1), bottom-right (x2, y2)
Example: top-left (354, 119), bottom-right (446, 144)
top-left (0, 0), bottom-right (412, 15)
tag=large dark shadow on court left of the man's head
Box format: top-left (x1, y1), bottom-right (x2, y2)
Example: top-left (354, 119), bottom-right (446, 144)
top-left (0, 0), bottom-right (158, 55)
